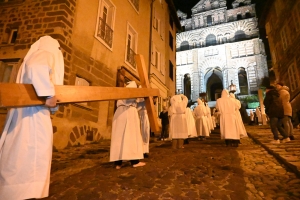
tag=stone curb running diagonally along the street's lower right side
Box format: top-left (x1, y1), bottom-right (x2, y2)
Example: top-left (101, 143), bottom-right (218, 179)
top-left (247, 132), bottom-right (300, 178)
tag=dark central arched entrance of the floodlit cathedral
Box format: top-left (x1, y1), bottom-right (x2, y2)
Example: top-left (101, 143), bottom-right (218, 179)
top-left (206, 69), bottom-right (223, 101)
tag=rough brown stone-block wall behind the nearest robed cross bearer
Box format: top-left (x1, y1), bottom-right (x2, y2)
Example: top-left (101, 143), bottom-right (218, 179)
top-left (0, 0), bottom-right (116, 149)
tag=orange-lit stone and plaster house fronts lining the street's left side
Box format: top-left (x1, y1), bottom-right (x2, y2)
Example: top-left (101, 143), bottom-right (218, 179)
top-left (0, 0), bottom-right (180, 148)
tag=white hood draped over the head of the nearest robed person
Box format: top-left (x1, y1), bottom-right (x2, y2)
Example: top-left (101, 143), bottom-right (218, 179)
top-left (16, 36), bottom-right (64, 85)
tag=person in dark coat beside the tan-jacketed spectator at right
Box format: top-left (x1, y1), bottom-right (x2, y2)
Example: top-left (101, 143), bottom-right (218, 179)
top-left (264, 86), bottom-right (288, 144)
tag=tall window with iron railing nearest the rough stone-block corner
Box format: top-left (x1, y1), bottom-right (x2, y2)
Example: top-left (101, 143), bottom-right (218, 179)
top-left (95, 0), bottom-right (116, 49)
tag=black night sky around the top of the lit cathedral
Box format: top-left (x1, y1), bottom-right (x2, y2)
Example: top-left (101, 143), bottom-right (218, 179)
top-left (173, 0), bottom-right (266, 17)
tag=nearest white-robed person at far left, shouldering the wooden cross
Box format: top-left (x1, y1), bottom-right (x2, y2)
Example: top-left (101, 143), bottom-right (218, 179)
top-left (0, 36), bottom-right (64, 200)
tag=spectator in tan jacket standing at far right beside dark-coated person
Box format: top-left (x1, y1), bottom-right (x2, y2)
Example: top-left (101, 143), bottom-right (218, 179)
top-left (276, 83), bottom-right (295, 142)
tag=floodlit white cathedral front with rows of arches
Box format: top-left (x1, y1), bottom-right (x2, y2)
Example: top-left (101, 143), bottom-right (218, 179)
top-left (176, 0), bottom-right (268, 103)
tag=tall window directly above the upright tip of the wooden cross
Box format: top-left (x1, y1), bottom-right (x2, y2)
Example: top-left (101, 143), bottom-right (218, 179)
top-left (125, 24), bottom-right (138, 69)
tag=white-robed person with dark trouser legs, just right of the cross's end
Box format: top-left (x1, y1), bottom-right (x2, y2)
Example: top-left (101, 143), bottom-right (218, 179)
top-left (169, 94), bottom-right (188, 149)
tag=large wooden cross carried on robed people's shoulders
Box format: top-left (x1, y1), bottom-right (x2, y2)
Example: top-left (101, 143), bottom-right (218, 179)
top-left (0, 55), bottom-right (160, 133)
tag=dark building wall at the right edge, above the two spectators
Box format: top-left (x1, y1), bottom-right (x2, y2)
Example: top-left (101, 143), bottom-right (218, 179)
top-left (261, 0), bottom-right (300, 123)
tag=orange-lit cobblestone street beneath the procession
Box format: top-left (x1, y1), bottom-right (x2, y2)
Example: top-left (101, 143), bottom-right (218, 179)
top-left (46, 126), bottom-right (300, 200)
